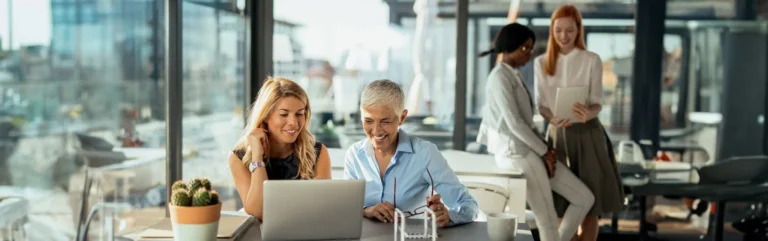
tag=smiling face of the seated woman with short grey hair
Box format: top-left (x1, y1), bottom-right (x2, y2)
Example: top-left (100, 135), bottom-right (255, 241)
top-left (362, 105), bottom-right (408, 150)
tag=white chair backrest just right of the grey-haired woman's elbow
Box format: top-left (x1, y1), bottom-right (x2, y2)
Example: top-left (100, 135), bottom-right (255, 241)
top-left (463, 182), bottom-right (509, 213)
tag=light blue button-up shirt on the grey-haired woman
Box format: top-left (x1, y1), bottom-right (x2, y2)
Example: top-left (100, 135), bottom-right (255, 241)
top-left (344, 130), bottom-right (479, 225)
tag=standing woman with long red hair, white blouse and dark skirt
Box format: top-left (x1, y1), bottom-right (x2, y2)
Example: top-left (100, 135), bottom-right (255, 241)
top-left (534, 5), bottom-right (624, 241)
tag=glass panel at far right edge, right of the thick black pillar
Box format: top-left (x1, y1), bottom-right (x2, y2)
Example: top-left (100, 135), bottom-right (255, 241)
top-left (686, 20), bottom-right (768, 161)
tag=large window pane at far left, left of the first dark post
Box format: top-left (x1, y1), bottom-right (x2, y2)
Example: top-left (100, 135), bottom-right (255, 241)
top-left (0, 0), bottom-right (166, 240)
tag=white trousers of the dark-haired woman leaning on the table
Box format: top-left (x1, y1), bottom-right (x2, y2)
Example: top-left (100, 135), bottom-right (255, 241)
top-left (495, 151), bottom-right (595, 241)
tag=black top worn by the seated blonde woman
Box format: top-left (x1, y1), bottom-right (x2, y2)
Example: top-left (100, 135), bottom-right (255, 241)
top-left (232, 142), bottom-right (323, 180)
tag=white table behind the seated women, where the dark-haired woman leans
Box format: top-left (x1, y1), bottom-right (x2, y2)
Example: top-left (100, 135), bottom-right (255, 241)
top-left (328, 148), bottom-right (526, 222)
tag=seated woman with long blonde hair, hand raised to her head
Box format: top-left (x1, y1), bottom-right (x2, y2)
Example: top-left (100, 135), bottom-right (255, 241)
top-left (229, 77), bottom-right (331, 221)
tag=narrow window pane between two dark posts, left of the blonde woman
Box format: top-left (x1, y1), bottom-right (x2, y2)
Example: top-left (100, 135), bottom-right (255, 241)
top-left (182, 1), bottom-right (248, 211)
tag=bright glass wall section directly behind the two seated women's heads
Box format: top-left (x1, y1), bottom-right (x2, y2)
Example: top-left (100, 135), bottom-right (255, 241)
top-left (273, 0), bottom-right (456, 154)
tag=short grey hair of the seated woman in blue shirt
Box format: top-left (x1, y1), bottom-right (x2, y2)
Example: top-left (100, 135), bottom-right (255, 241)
top-left (360, 79), bottom-right (405, 118)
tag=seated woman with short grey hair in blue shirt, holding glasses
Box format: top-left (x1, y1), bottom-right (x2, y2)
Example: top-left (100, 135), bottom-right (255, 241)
top-left (344, 80), bottom-right (478, 227)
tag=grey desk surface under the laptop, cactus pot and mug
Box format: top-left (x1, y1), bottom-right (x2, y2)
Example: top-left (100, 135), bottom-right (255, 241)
top-left (137, 219), bottom-right (533, 241)
